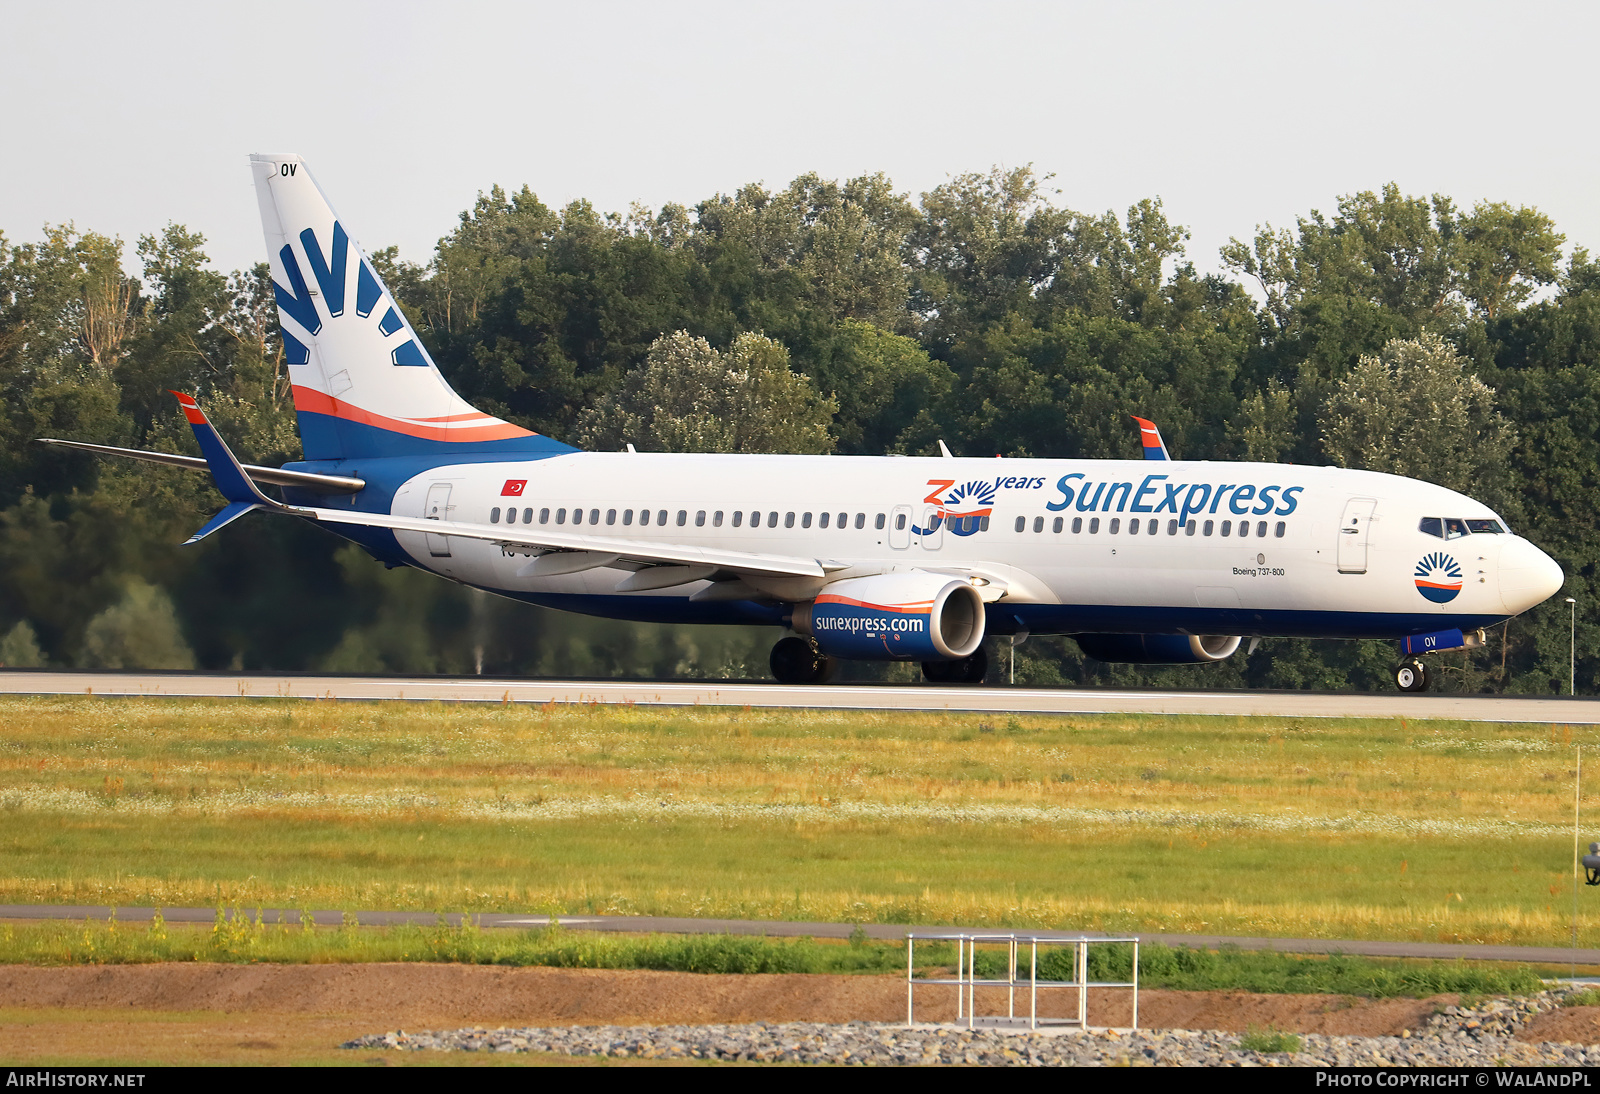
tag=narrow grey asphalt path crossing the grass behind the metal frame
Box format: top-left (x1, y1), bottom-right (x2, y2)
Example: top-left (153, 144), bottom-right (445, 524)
top-left (0, 904), bottom-right (1600, 968)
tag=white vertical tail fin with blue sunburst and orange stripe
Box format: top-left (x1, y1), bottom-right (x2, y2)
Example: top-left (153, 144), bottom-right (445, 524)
top-left (250, 155), bottom-right (573, 461)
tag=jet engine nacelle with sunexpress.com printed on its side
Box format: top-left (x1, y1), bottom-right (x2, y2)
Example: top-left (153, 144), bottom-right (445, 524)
top-left (792, 569), bottom-right (984, 661)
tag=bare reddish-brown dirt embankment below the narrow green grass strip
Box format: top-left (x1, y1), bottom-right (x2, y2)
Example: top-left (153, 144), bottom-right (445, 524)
top-left (0, 964), bottom-right (1465, 1040)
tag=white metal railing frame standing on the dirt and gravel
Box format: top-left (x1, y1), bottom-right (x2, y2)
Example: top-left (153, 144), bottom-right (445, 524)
top-left (906, 931), bottom-right (1139, 1030)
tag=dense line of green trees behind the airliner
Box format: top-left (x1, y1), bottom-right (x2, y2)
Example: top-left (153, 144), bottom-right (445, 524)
top-left (0, 168), bottom-right (1600, 693)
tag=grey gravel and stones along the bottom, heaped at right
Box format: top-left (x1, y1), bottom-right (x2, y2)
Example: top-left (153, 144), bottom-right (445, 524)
top-left (342, 990), bottom-right (1600, 1067)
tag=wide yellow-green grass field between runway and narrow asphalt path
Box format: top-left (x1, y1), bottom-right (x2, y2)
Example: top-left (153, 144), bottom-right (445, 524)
top-left (0, 697), bottom-right (1600, 945)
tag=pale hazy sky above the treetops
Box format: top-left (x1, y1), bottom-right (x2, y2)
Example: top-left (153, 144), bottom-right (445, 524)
top-left (0, 0), bottom-right (1600, 281)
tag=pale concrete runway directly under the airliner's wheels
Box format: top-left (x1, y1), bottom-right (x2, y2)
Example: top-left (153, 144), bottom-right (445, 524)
top-left (0, 669), bottom-right (1600, 725)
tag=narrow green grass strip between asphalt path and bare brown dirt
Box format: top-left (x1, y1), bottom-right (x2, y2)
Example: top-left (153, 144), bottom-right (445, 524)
top-left (0, 912), bottom-right (1541, 998)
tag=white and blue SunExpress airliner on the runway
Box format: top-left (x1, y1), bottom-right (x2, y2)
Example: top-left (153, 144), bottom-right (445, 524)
top-left (37, 155), bottom-right (1563, 691)
